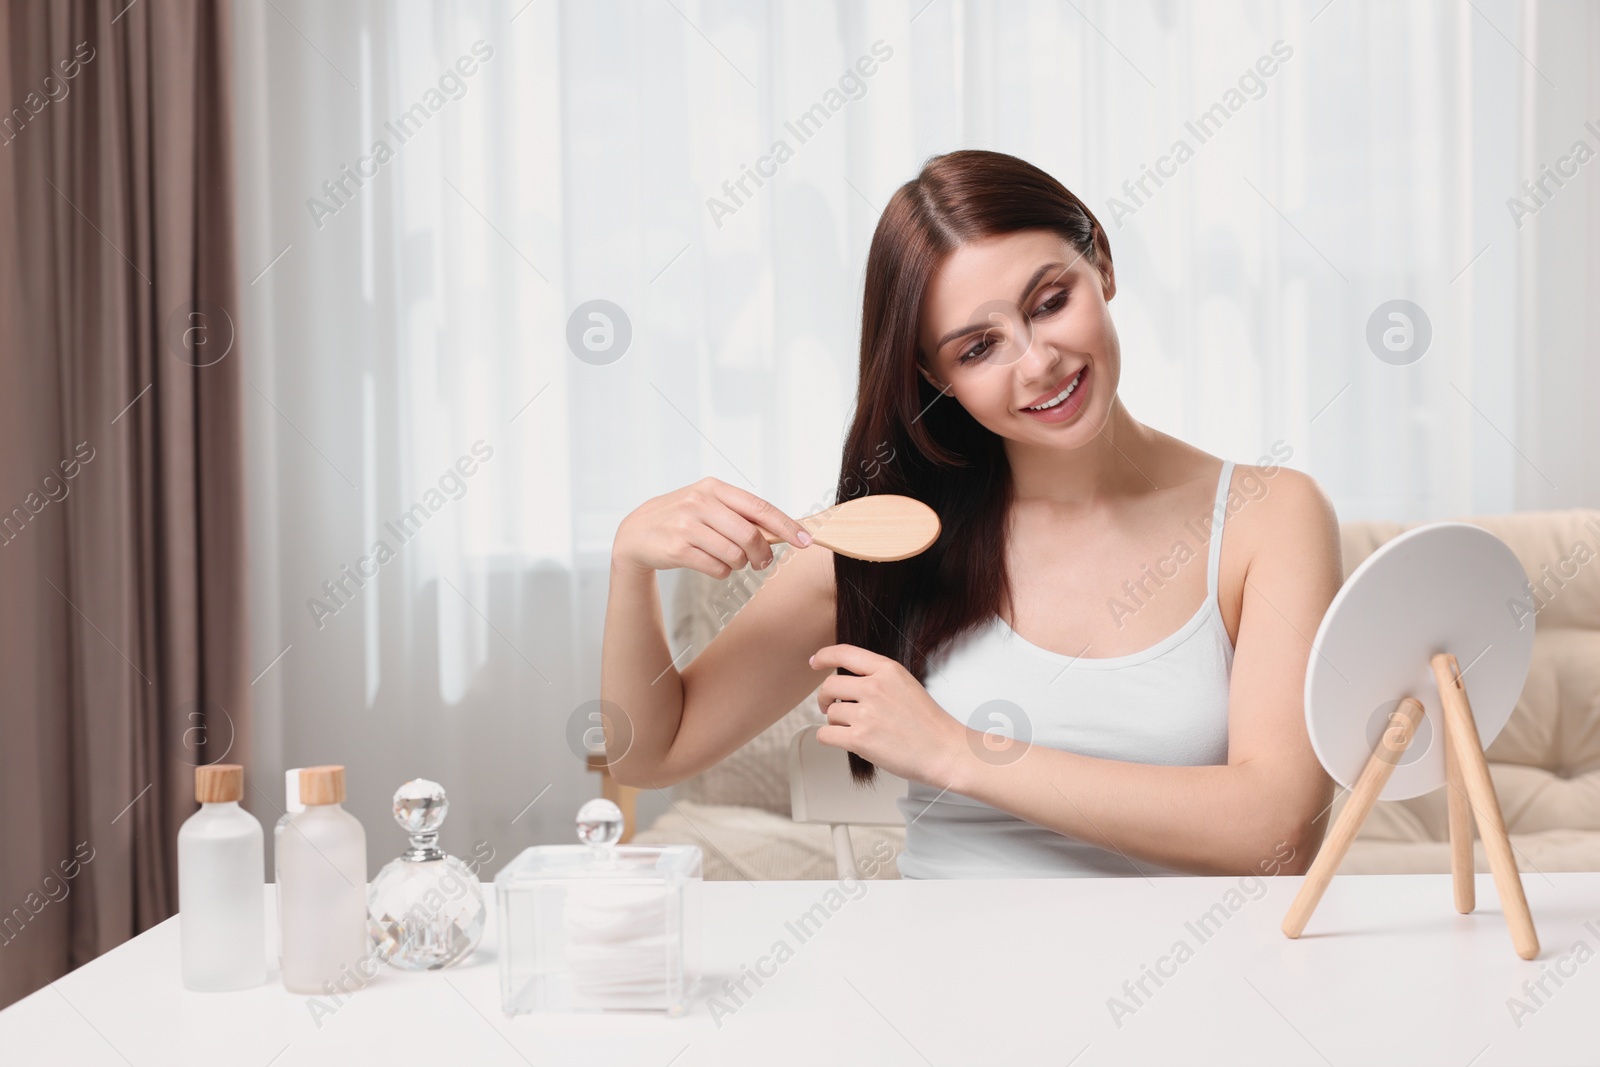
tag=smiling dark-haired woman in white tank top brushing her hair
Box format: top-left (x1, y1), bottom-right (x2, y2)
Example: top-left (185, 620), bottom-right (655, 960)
top-left (602, 152), bottom-right (1342, 878)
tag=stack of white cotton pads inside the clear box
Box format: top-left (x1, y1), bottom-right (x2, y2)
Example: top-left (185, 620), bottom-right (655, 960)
top-left (562, 881), bottom-right (682, 1009)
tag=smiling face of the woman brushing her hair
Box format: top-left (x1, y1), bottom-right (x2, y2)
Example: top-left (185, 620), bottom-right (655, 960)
top-left (918, 230), bottom-right (1122, 448)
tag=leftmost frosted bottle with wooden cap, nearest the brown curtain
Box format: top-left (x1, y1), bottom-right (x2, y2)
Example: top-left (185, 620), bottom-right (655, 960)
top-left (178, 763), bottom-right (267, 993)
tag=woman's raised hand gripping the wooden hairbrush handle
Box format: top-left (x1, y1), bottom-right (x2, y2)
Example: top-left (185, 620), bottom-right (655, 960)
top-left (611, 478), bottom-right (811, 579)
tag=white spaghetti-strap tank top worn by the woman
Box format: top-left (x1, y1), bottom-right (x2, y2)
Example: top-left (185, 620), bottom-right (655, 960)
top-left (898, 461), bottom-right (1238, 878)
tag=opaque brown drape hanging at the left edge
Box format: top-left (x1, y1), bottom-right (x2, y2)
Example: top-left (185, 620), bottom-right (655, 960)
top-left (0, 0), bottom-right (250, 1006)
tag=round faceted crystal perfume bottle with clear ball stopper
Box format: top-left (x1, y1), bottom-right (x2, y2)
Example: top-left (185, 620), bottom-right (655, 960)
top-left (366, 777), bottom-right (486, 971)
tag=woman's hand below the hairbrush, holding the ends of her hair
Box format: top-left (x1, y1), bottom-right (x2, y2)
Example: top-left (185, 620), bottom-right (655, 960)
top-left (811, 645), bottom-right (971, 789)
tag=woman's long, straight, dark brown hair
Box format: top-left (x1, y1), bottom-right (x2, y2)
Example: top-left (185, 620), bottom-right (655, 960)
top-left (834, 150), bottom-right (1110, 784)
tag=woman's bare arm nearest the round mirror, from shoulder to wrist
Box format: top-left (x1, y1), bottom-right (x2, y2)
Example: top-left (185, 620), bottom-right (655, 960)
top-left (947, 467), bottom-right (1342, 875)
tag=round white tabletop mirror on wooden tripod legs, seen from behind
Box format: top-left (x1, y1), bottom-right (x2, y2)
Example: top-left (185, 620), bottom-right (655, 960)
top-left (1283, 523), bottom-right (1539, 960)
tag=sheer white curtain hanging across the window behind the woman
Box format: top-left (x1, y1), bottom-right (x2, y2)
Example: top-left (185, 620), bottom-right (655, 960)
top-left (237, 0), bottom-right (1600, 859)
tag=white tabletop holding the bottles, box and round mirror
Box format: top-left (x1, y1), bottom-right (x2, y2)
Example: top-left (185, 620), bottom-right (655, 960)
top-left (0, 873), bottom-right (1600, 1067)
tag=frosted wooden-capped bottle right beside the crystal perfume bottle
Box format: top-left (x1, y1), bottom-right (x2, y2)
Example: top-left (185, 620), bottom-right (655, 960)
top-left (278, 766), bottom-right (376, 995)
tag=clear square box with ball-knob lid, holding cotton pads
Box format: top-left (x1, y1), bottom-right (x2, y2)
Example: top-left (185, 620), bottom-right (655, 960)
top-left (494, 800), bottom-right (702, 1016)
